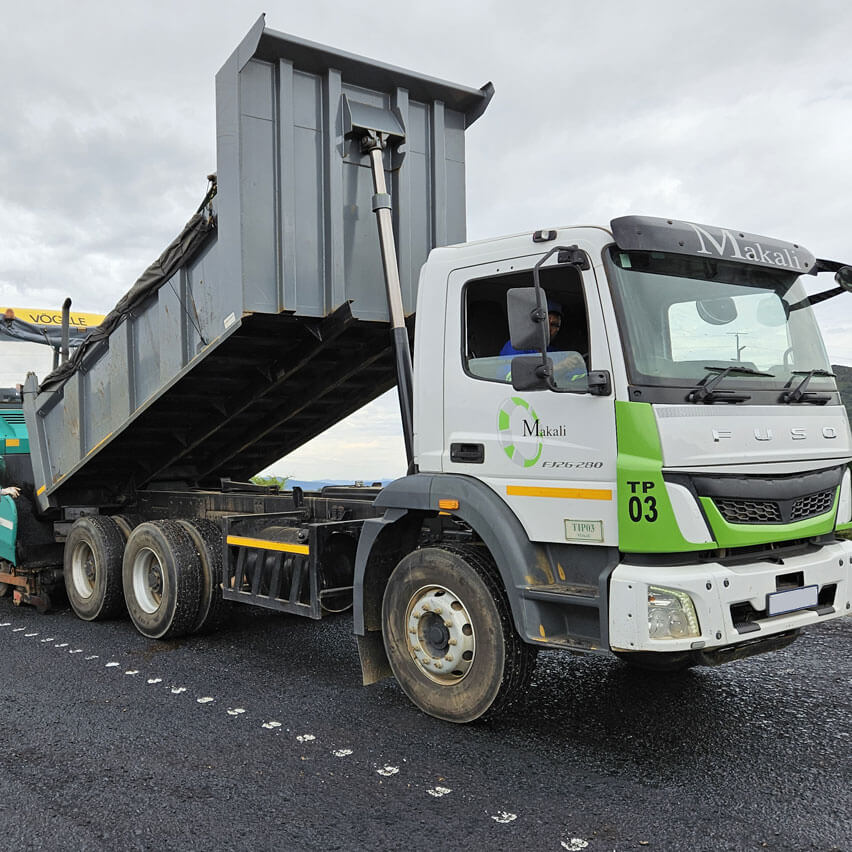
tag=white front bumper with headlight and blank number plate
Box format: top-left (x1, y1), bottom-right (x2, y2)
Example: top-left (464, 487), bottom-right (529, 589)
top-left (609, 540), bottom-right (852, 653)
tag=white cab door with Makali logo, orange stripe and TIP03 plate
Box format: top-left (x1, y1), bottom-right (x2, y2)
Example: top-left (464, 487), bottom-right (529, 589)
top-left (442, 246), bottom-right (618, 545)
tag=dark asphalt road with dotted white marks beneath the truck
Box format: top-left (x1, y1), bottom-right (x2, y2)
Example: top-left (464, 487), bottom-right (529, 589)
top-left (0, 598), bottom-right (852, 852)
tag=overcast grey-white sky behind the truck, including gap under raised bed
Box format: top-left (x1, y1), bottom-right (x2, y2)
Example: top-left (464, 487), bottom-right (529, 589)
top-left (0, 0), bottom-right (852, 479)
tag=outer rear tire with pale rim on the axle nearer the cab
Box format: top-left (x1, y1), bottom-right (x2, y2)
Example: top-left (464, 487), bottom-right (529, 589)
top-left (122, 521), bottom-right (202, 639)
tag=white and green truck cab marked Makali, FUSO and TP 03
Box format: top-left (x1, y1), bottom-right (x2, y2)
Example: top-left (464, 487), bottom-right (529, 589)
top-left (364, 217), bottom-right (852, 716)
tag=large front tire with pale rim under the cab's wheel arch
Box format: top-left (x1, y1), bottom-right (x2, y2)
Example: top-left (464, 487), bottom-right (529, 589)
top-left (382, 545), bottom-right (537, 722)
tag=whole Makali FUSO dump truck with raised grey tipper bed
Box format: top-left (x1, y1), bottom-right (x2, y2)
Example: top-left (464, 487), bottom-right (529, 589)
top-left (0, 18), bottom-right (852, 722)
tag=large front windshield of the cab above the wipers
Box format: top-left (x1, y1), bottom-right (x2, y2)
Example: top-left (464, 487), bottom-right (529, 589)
top-left (605, 246), bottom-right (835, 391)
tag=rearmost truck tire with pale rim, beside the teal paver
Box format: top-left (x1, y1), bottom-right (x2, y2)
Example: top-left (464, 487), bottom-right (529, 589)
top-left (63, 517), bottom-right (124, 621)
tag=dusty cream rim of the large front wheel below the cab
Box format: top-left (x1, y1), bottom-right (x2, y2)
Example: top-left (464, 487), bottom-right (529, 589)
top-left (405, 586), bottom-right (476, 686)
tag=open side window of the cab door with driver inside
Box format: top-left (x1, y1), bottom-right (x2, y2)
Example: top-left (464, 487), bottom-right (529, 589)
top-left (462, 266), bottom-right (589, 390)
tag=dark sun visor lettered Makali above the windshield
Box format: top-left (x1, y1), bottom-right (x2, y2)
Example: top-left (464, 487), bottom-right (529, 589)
top-left (610, 216), bottom-right (817, 275)
